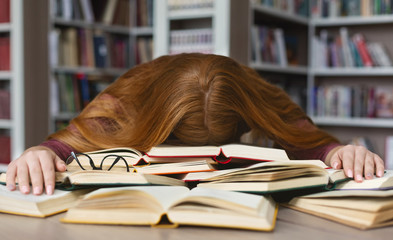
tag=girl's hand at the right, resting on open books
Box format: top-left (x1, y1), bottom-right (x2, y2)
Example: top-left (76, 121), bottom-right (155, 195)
top-left (326, 145), bottom-right (385, 182)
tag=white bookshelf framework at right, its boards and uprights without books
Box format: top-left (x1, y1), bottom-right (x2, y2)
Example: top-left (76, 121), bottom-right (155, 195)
top-left (248, 1), bottom-right (393, 156)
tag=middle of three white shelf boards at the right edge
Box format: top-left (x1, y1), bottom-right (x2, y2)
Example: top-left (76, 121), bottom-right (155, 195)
top-left (310, 67), bottom-right (393, 77)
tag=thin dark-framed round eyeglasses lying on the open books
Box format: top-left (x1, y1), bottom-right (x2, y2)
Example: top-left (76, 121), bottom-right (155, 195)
top-left (66, 152), bottom-right (130, 172)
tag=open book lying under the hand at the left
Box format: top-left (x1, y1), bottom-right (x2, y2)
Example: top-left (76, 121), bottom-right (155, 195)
top-left (0, 185), bottom-right (88, 217)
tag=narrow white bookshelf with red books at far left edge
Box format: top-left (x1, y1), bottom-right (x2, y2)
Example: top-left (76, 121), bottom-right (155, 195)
top-left (0, 0), bottom-right (25, 171)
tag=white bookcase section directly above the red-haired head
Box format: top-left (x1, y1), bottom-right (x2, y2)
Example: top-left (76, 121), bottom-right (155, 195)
top-left (154, 0), bottom-right (249, 63)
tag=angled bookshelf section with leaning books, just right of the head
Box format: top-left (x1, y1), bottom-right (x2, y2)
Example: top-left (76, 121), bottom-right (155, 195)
top-left (248, 0), bottom-right (310, 110)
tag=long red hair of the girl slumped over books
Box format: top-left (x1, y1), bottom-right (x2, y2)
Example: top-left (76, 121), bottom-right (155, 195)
top-left (49, 53), bottom-right (337, 151)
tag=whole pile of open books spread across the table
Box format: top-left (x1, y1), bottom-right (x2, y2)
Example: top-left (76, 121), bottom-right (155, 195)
top-left (0, 144), bottom-right (393, 231)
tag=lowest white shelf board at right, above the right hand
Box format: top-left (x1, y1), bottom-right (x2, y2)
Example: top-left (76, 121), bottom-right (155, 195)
top-left (312, 117), bottom-right (393, 128)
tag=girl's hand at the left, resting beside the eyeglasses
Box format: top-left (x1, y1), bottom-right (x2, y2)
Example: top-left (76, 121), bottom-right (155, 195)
top-left (6, 146), bottom-right (66, 195)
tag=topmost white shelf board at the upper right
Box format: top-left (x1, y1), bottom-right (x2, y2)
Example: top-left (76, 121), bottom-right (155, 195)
top-left (310, 15), bottom-right (393, 27)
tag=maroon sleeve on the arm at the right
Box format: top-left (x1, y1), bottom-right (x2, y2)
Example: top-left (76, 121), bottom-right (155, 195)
top-left (287, 119), bottom-right (341, 161)
